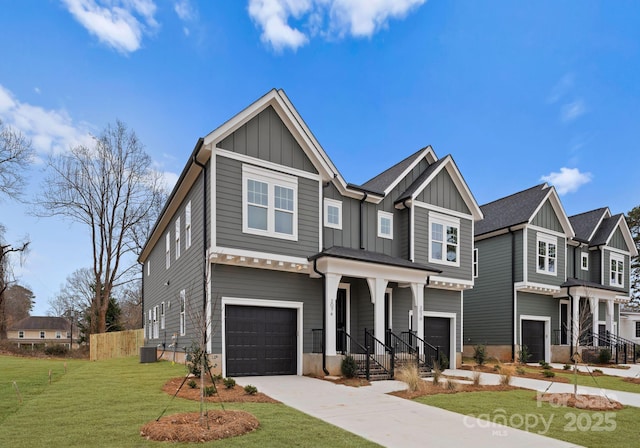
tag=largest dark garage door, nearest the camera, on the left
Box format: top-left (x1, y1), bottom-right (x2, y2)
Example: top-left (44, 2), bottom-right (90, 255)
top-left (225, 305), bottom-right (297, 376)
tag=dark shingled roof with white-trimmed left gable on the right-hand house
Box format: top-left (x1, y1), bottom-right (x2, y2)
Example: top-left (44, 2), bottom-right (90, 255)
top-left (475, 183), bottom-right (574, 237)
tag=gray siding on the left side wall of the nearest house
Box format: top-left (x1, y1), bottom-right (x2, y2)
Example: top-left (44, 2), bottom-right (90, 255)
top-left (142, 165), bottom-right (211, 344)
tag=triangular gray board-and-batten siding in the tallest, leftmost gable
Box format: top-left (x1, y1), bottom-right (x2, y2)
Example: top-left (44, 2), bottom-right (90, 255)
top-left (217, 106), bottom-right (318, 174)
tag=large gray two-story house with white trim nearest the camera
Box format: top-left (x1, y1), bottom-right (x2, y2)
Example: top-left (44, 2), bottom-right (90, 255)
top-left (139, 90), bottom-right (482, 376)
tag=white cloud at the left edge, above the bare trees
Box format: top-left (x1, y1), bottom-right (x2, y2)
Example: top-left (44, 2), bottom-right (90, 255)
top-left (0, 85), bottom-right (93, 153)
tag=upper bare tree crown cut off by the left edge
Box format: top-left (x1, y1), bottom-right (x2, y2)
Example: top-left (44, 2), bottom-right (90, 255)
top-left (0, 120), bottom-right (32, 199)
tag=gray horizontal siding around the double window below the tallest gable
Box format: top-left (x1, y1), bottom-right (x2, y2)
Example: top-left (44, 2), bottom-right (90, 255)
top-left (215, 156), bottom-right (320, 258)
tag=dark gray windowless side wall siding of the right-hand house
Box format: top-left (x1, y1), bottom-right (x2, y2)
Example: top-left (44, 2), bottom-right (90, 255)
top-left (464, 234), bottom-right (513, 345)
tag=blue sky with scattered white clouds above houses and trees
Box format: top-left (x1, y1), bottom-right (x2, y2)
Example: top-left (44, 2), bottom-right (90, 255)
top-left (0, 0), bottom-right (640, 314)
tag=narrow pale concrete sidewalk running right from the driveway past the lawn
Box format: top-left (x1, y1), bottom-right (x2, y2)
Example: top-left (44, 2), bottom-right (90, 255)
top-left (443, 369), bottom-right (640, 407)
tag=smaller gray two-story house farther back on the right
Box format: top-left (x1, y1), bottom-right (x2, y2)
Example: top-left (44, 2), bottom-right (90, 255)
top-left (464, 184), bottom-right (637, 362)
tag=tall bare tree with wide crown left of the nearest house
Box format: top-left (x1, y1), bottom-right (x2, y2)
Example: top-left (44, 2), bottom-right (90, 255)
top-left (34, 121), bottom-right (165, 333)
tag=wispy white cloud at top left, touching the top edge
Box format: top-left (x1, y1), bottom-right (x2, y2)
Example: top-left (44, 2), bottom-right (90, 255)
top-left (62, 0), bottom-right (158, 53)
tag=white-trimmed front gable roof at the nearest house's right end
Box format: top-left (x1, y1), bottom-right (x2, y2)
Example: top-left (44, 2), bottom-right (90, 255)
top-left (395, 154), bottom-right (483, 220)
